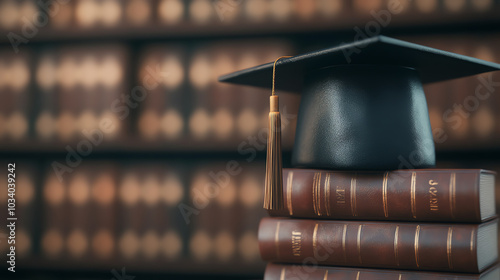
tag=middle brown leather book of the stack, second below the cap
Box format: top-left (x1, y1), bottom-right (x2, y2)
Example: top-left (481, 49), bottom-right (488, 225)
top-left (259, 218), bottom-right (498, 273)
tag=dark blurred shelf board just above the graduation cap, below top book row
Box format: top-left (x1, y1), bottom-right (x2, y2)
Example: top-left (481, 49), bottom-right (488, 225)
top-left (0, 7), bottom-right (500, 46)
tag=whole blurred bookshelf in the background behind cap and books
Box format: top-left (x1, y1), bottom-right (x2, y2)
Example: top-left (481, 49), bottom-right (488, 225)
top-left (0, 0), bottom-right (500, 279)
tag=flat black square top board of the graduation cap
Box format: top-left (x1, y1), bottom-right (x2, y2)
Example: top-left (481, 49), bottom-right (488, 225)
top-left (219, 36), bottom-right (500, 92)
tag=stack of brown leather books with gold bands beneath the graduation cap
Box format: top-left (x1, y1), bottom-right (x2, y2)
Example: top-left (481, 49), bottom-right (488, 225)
top-left (259, 169), bottom-right (500, 280)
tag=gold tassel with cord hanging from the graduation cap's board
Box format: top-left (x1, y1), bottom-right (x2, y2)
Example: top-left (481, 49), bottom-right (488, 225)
top-left (264, 56), bottom-right (289, 210)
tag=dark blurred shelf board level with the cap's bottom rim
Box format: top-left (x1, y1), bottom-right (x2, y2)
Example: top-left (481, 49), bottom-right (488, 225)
top-left (0, 139), bottom-right (500, 158)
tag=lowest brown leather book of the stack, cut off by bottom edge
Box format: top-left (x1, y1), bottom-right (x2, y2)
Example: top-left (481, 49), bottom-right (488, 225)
top-left (264, 264), bottom-right (500, 280)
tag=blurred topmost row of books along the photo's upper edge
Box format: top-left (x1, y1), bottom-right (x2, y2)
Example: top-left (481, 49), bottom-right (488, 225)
top-left (0, 0), bottom-right (500, 41)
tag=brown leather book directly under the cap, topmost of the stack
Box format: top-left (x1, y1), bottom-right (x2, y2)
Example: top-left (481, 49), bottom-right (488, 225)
top-left (269, 169), bottom-right (496, 223)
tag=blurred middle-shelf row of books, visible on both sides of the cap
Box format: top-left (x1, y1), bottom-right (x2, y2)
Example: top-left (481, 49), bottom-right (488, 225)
top-left (0, 34), bottom-right (500, 148)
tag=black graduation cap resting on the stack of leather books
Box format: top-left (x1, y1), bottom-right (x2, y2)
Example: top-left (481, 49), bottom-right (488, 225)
top-left (219, 36), bottom-right (500, 170)
